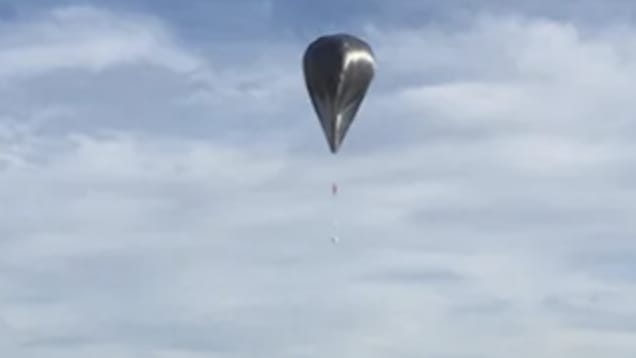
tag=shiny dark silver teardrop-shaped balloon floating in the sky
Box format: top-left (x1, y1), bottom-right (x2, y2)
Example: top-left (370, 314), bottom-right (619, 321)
top-left (303, 34), bottom-right (375, 154)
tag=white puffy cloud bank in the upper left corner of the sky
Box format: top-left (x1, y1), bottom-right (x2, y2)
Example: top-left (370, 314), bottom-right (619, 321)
top-left (0, 7), bottom-right (200, 77)
